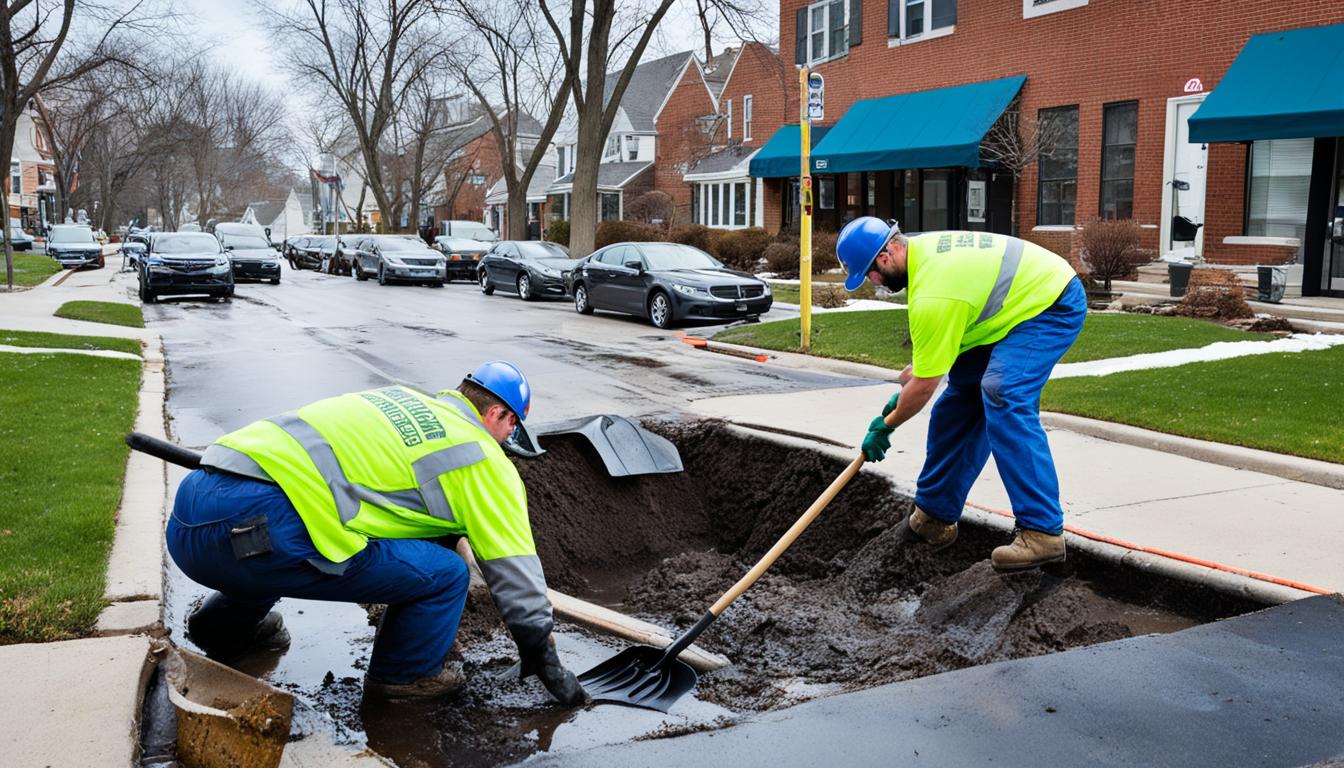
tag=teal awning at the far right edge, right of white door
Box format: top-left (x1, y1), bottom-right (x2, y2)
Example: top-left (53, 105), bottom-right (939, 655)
top-left (1189, 24), bottom-right (1344, 144)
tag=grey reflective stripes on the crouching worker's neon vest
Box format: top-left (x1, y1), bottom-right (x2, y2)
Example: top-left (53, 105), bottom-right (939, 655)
top-left (266, 413), bottom-right (485, 525)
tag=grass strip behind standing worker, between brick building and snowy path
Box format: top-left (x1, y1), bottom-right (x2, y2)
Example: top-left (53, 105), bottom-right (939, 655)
top-left (714, 309), bottom-right (1271, 369)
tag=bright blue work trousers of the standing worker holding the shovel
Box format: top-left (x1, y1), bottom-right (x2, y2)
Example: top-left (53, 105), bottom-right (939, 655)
top-left (915, 278), bottom-right (1087, 534)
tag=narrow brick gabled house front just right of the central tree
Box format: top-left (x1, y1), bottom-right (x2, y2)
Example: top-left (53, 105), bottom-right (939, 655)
top-left (653, 62), bottom-right (715, 222)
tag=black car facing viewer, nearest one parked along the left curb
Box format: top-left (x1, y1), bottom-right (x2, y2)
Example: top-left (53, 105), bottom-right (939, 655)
top-left (137, 233), bottom-right (234, 304)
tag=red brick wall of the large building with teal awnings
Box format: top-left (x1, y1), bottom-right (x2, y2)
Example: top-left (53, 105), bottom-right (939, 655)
top-left (780, 0), bottom-right (1344, 258)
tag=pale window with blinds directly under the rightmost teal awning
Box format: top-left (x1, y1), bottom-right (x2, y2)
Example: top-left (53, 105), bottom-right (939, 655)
top-left (1246, 139), bottom-right (1314, 248)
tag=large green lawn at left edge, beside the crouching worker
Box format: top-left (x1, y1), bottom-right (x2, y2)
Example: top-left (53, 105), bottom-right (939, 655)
top-left (0, 354), bottom-right (140, 643)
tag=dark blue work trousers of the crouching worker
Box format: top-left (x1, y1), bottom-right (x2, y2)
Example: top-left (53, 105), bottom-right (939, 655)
top-left (167, 469), bottom-right (469, 683)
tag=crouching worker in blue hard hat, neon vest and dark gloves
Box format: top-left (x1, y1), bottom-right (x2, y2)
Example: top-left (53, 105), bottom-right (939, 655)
top-left (167, 362), bottom-right (585, 703)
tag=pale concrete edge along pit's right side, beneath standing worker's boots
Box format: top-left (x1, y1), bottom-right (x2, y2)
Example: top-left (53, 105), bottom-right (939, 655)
top-left (726, 421), bottom-right (1316, 605)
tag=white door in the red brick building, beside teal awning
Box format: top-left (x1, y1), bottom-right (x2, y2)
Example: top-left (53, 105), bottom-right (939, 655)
top-left (1161, 94), bottom-right (1208, 260)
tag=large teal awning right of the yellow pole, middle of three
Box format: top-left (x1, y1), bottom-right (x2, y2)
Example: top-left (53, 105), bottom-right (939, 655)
top-left (812, 75), bottom-right (1027, 174)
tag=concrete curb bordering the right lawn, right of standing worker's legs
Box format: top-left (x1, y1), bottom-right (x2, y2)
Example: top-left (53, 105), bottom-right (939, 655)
top-left (1040, 412), bottom-right (1344, 490)
